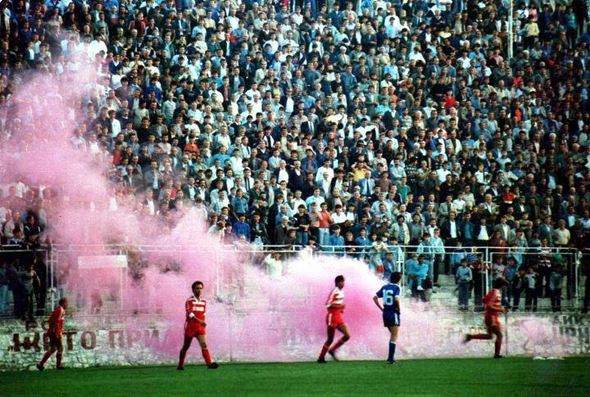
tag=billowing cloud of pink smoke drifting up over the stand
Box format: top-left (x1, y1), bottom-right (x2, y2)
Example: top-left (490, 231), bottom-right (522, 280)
top-left (0, 65), bottom-right (567, 361)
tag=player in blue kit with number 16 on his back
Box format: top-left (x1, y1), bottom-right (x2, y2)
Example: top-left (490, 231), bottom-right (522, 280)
top-left (373, 272), bottom-right (402, 364)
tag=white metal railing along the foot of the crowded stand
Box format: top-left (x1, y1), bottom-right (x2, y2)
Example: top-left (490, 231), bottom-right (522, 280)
top-left (0, 242), bottom-right (590, 316)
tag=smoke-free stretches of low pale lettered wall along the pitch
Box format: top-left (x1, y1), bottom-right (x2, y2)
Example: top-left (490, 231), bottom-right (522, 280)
top-left (0, 312), bottom-right (590, 371)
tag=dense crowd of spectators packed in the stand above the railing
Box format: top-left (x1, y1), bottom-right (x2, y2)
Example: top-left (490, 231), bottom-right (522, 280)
top-left (0, 0), bottom-right (590, 310)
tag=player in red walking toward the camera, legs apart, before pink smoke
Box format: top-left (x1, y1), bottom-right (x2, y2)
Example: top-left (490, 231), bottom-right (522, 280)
top-left (177, 281), bottom-right (218, 370)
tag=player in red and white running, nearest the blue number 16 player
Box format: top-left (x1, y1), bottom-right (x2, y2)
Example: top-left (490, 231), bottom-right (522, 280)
top-left (318, 275), bottom-right (350, 364)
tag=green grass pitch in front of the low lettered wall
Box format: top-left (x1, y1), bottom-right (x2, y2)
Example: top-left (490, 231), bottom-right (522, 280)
top-left (0, 357), bottom-right (590, 397)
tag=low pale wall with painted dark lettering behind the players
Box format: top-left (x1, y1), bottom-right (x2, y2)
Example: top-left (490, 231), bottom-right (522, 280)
top-left (0, 310), bottom-right (590, 371)
